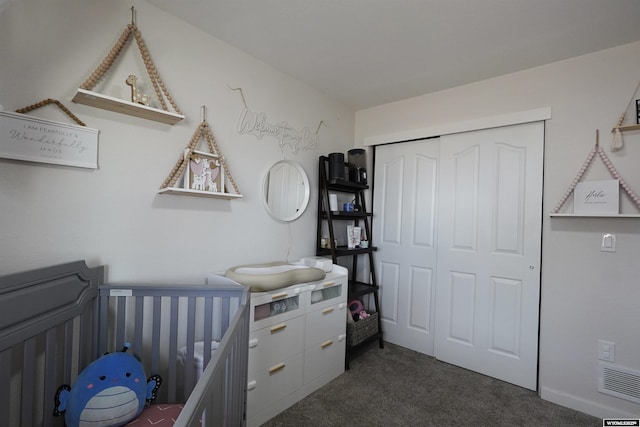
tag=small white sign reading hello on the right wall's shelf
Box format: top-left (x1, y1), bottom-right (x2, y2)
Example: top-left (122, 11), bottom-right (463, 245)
top-left (573, 179), bottom-right (620, 214)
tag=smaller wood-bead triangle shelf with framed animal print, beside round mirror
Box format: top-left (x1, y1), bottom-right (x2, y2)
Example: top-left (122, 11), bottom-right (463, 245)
top-left (158, 106), bottom-right (242, 199)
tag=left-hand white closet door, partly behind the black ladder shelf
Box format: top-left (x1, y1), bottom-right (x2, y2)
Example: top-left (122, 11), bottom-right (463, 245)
top-left (373, 139), bottom-right (438, 355)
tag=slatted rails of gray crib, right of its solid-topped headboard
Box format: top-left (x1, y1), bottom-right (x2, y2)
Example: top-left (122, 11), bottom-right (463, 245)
top-left (98, 281), bottom-right (250, 426)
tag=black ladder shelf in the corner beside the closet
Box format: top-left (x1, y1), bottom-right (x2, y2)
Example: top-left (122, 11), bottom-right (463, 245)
top-left (316, 156), bottom-right (384, 369)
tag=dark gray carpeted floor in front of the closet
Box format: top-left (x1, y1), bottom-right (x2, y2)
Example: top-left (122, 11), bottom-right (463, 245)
top-left (264, 343), bottom-right (602, 427)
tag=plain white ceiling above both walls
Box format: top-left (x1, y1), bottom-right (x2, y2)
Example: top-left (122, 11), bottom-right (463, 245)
top-left (148, 0), bottom-right (640, 110)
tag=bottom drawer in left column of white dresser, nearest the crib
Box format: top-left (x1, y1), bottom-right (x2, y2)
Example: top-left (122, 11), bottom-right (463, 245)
top-left (247, 353), bottom-right (304, 418)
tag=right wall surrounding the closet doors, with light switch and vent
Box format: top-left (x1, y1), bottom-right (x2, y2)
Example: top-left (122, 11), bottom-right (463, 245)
top-left (356, 43), bottom-right (640, 417)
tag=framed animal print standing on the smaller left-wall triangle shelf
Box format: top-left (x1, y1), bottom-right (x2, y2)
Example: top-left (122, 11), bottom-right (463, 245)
top-left (184, 151), bottom-right (224, 193)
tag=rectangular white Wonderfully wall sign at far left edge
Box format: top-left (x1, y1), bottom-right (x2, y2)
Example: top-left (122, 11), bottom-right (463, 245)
top-left (0, 111), bottom-right (99, 169)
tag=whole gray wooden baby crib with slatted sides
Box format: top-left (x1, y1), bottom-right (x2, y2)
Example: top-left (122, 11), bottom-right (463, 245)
top-left (0, 261), bottom-right (250, 427)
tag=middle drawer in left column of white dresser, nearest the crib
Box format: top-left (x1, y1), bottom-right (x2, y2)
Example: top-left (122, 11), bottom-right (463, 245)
top-left (249, 316), bottom-right (304, 370)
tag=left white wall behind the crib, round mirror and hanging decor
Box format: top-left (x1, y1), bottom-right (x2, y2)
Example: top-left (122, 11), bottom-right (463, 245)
top-left (0, 0), bottom-right (354, 283)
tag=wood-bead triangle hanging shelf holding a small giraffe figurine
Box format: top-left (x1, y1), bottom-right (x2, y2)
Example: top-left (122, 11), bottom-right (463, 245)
top-left (72, 6), bottom-right (185, 125)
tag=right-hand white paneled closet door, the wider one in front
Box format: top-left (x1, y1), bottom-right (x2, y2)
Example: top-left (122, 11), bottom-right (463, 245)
top-left (432, 122), bottom-right (544, 390)
